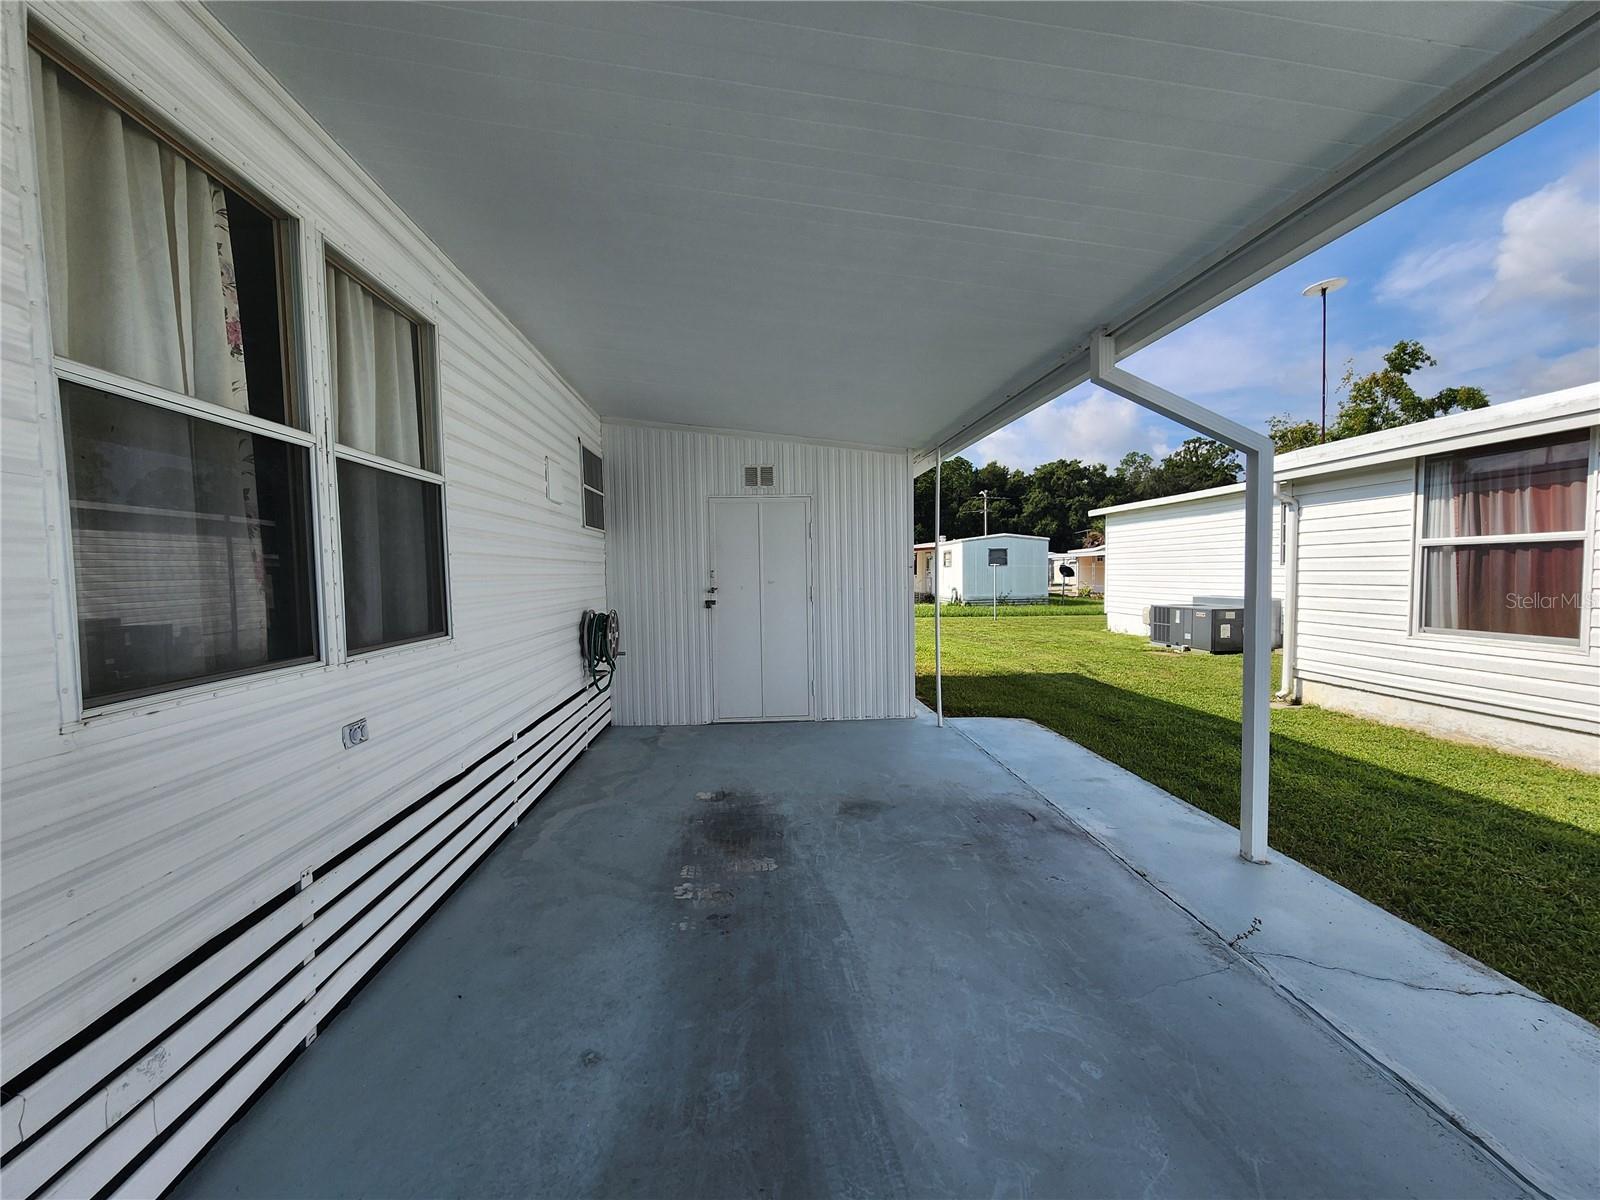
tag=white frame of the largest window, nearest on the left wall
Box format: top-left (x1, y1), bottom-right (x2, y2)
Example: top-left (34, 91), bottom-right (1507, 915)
top-left (18, 37), bottom-right (331, 733)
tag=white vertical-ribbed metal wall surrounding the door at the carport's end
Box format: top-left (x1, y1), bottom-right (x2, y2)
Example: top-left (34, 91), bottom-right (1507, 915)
top-left (605, 424), bottom-right (914, 725)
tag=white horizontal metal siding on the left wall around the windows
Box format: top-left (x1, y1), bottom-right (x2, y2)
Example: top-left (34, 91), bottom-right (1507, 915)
top-left (0, 5), bottom-right (605, 1078)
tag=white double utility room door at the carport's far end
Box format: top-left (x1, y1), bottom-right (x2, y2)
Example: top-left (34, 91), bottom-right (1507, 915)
top-left (707, 496), bottom-right (811, 722)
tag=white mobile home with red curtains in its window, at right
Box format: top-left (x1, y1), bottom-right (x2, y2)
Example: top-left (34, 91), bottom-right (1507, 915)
top-left (1102, 384), bottom-right (1600, 770)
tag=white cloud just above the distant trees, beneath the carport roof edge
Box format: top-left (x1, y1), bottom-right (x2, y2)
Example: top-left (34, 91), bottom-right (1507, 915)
top-left (962, 386), bottom-right (1176, 470)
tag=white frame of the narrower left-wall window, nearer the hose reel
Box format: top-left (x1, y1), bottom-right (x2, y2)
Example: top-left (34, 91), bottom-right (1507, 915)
top-left (315, 241), bottom-right (456, 666)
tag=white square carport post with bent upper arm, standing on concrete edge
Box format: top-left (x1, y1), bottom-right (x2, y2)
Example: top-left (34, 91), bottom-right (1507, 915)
top-left (1090, 330), bottom-right (1274, 862)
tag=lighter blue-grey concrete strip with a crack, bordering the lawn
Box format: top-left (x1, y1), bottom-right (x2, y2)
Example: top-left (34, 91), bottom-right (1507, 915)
top-left (950, 718), bottom-right (1600, 1197)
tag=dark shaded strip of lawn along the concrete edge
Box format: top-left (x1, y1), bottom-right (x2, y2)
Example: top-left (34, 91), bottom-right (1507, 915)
top-left (917, 672), bottom-right (1600, 1022)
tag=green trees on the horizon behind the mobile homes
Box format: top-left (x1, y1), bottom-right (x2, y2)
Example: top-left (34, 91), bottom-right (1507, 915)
top-left (914, 341), bottom-right (1490, 550)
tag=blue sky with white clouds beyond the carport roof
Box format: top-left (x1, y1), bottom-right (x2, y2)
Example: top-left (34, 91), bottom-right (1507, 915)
top-left (963, 96), bottom-right (1600, 470)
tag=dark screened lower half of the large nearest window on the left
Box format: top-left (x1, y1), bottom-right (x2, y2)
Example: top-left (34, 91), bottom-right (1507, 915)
top-left (61, 382), bottom-right (317, 704)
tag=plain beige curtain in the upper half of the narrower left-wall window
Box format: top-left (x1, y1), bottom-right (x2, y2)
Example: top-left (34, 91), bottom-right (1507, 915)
top-left (328, 267), bottom-right (422, 467)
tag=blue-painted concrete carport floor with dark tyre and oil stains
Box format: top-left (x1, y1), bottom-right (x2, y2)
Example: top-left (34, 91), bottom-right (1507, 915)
top-left (178, 722), bottom-right (1523, 1198)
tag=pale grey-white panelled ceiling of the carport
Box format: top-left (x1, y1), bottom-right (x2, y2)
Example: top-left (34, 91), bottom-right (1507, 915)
top-left (213, 3), bottom-right (1573, 448)
